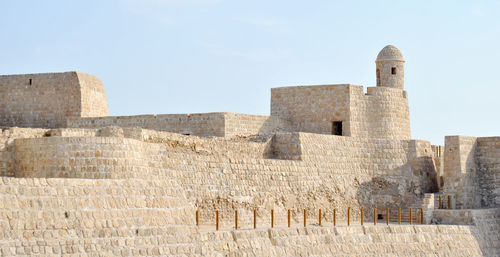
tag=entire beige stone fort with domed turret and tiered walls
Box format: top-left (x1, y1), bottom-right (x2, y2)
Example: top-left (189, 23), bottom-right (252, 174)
top-left (0, 45), bottom-right (500, 256)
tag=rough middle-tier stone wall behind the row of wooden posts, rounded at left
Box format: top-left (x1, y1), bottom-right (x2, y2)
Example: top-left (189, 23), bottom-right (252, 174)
top-left (10, 128), bottom-right (435, 227)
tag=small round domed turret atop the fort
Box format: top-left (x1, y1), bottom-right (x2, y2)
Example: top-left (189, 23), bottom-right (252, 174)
top-left (375, 45), bottom-right (405, 89)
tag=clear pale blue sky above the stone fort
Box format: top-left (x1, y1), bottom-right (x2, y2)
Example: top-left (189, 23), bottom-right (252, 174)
top-left (0, 0), bottom-right (500, 144)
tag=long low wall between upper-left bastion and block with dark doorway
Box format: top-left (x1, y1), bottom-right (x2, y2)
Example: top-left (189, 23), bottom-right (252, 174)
top-left (67, 112), bottom-right (291, 137)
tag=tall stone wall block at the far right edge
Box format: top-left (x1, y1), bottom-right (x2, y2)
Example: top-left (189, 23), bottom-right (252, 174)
top-left (443, 136), bottom-right (500, 209)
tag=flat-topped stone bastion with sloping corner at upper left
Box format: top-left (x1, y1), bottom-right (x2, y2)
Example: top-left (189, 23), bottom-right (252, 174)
top-left (0, 72), bottom-right (108, 128)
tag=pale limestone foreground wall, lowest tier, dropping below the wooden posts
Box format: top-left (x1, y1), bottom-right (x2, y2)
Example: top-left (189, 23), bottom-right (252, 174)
top-left (0, 175), bottom-right (494, 256)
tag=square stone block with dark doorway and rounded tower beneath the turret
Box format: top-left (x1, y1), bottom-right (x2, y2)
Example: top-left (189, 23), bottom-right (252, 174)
top-left (271, 84), bottom-right (411, 139)
